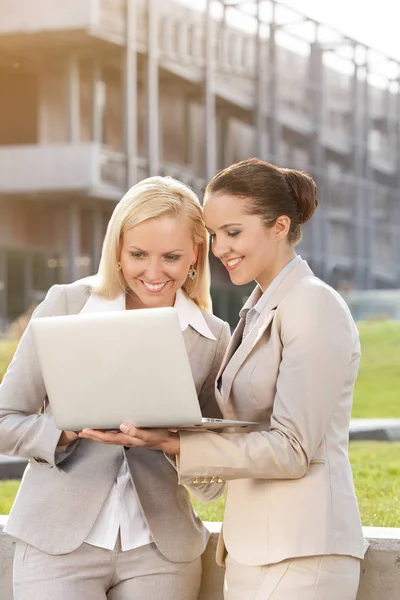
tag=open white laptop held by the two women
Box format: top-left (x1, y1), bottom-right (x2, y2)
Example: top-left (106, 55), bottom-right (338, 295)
top-left (31, 308), bottom-right (255, 431)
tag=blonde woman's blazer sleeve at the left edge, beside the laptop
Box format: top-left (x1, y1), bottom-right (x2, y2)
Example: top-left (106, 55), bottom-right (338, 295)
top-left (0, 285), bottom-right (75, 467)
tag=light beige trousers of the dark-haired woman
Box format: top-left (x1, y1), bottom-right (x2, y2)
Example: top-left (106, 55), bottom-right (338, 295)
top-left (224, 555), bottom-right (360, 600)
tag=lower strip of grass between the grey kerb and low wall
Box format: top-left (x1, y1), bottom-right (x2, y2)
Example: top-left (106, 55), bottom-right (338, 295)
top-left (0, 442), bottom-right (400, 527)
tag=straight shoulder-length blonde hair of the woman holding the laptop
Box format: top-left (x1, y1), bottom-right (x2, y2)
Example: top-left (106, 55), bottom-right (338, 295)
top-left (93, 176), bottom-right (211, 311)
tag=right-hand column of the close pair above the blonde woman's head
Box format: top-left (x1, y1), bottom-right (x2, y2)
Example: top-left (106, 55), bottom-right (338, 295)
top-left (147, 0), bottom-right (160, 177)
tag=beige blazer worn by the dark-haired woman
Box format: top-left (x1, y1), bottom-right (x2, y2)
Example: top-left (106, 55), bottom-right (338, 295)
top-left (179, 261), bottom-right (366, 565)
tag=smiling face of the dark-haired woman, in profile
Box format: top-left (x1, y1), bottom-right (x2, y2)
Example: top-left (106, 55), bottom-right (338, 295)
top-left (204, 193), bottom-right (294, 291)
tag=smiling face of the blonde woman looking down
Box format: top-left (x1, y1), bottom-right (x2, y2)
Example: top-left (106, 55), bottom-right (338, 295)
top-left (120, 217), bottom-right (198, 308)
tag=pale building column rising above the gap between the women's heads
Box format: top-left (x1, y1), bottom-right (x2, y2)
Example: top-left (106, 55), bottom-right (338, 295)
top-left (203, 0), bottom-right (217, 183)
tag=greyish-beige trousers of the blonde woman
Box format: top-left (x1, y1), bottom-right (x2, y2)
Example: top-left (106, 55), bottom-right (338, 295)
top-left (14, 541), bottom-right (201, 600)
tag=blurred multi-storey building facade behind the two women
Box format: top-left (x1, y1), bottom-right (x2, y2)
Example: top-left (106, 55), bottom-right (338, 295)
top-left (0, 0), bottom-right (400, 326)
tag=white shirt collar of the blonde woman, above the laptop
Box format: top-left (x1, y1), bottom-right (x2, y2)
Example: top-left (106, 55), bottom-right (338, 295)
top-left (80, 290), bottom-right (216, 341)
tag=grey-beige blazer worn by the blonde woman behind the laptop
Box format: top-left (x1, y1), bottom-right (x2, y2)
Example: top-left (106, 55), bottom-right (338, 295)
top-left (0, 280), bottom-right (230, 562)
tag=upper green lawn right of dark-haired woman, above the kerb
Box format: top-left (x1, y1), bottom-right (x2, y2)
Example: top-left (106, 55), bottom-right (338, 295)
top-left (352, 321), bottom-right (400, 418)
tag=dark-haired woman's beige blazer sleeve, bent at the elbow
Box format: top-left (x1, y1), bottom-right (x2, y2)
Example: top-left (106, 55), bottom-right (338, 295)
top-left (178, 286), bottom-right (360, 483)
